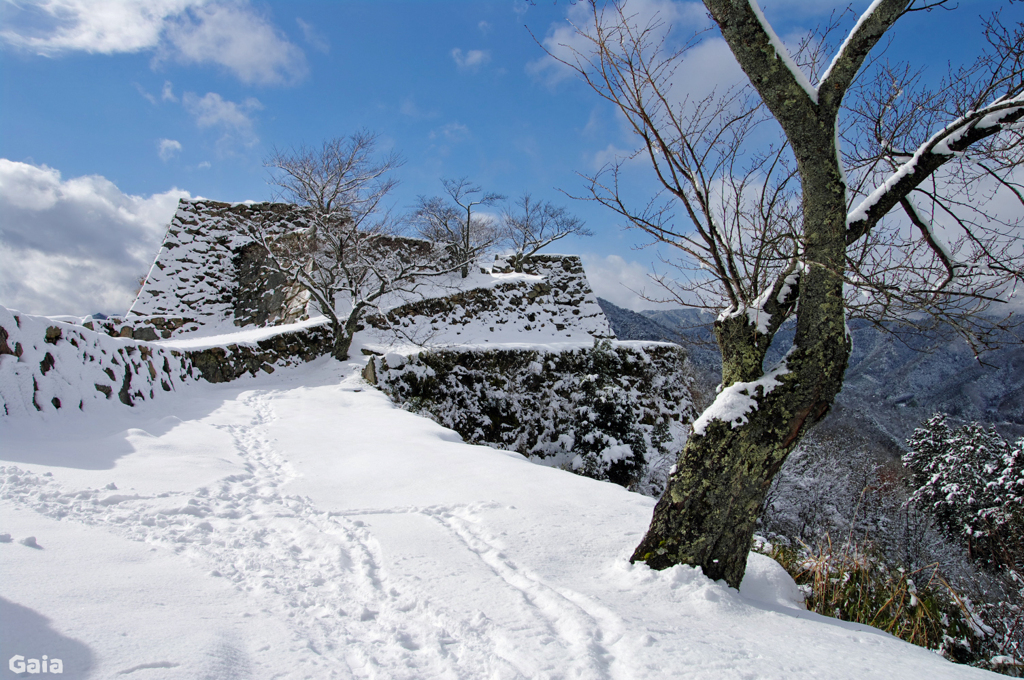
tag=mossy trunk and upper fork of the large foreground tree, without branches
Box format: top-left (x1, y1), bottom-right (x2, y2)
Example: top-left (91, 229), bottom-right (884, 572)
top-left (631, 0), bottom-right (909, 588)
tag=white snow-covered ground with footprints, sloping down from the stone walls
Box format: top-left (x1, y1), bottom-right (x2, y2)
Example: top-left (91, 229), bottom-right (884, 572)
top-left (0, 357), bottom-right (985, 680)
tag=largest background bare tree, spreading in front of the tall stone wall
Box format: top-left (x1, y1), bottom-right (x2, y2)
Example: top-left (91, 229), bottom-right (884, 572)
top-left (251, 131), bottom-right (442, 359)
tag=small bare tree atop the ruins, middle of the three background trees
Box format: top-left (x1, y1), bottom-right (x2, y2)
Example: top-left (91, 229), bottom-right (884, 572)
top-left (413, 177), bottom-right (505, 279)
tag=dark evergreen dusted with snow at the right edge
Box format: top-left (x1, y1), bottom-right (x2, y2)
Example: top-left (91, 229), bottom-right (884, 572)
top-left (903, 414), bottom-right (1024, 569)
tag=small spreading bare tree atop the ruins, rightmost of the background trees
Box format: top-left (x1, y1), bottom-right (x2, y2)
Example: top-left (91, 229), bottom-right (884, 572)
top-left (500, 193), bottom-right (593, 272)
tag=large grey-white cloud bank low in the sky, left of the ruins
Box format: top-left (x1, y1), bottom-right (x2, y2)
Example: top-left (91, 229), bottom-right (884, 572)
top-left (0, 159), bottom-right (188, 315)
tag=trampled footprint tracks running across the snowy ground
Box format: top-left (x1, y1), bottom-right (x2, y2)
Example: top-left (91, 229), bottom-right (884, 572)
top-left (0, 391), bottom-right (629, 678)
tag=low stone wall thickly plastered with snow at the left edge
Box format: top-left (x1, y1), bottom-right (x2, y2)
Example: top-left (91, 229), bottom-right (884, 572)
top-left (0, 307), bottom-right (199, 416)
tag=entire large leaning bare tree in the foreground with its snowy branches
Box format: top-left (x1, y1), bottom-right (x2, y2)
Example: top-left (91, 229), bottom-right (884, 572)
top-left (556, 0), bottom-right (1024, 587)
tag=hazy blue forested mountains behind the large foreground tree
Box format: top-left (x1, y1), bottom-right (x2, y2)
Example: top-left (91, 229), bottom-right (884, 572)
top-left (598, 299), bottom-right (1024, 456)
